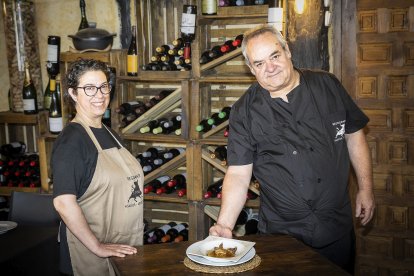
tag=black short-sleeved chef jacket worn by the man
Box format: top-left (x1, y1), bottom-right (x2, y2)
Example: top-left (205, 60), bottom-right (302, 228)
top-left (227, 70), bottom-right (368, 247)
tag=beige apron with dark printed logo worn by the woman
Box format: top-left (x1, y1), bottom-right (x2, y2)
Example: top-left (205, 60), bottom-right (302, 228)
top-left (67, 118), bottom-right (144, 276)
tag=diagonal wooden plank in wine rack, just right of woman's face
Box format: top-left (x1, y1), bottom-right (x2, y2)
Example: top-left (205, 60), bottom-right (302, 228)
top-left (122, 87), bottom-right (181, 134)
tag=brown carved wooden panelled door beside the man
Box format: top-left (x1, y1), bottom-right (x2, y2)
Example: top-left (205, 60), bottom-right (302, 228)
top-left (335, 0), bottom-right (414, 275)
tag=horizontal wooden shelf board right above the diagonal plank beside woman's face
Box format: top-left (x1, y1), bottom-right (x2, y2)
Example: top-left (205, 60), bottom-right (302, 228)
top-left (117, 70), bottom-right (191, 82)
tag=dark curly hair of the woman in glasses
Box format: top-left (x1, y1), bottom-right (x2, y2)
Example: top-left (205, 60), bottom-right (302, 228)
top-left (63, 59), bottom-right (110, 105)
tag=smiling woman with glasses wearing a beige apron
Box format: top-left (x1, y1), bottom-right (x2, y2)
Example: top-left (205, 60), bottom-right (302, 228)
top-left (51, 60), bottom-right (144, 275)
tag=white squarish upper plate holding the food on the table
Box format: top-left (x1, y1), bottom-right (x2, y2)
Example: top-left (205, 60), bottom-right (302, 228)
top-left (186, 236), bottom-right (255, 263)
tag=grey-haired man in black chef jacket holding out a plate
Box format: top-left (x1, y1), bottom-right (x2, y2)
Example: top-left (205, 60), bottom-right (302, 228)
top-left (210, 26), bottom-right (375, 272)
